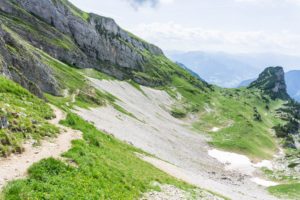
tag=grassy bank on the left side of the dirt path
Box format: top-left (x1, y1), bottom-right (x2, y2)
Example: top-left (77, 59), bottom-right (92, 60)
top-left (0, 76), bottom-right (58, 156)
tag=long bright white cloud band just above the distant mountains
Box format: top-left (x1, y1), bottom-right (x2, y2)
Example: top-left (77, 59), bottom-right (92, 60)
top-left (131, 22), bottom-right (300, 54)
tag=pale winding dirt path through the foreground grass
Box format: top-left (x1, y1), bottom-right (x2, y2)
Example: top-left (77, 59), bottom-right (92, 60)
top-left (0, 106), bottom-right (81, 188)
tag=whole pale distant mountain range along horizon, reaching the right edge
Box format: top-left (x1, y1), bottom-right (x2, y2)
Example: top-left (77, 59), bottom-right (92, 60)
top-left (165, 51), bottom-right (300, 88)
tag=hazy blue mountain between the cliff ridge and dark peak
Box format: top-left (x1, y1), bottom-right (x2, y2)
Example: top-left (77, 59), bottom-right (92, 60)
top-left (166, 52), bottom-right (257, 87)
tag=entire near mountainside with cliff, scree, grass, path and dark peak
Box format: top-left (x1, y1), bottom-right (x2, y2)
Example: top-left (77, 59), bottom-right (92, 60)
top-left (0, 0), bottom-right (300, 200)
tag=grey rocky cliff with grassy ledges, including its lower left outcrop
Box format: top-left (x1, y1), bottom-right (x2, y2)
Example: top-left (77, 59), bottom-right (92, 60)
top-left (0, 0), bottom-right (201, 95)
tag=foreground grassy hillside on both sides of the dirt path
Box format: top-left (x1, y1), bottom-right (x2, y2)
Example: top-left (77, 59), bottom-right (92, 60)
top-left (0, 77), bottom-right (223, 200)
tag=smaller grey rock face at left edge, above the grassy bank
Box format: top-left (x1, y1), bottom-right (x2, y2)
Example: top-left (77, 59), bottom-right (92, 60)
top-left (0, 27), bottom-right (59, 97)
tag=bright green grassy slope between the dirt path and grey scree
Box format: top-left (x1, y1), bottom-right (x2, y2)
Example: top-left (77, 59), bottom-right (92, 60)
top-left (4, 113), bottom-right (195, 200)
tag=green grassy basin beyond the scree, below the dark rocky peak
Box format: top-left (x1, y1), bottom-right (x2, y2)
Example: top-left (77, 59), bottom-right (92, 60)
top-left (168, 77), bottom-right (283, 160)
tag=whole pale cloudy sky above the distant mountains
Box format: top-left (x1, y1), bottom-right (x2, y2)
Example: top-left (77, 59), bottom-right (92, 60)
top-left (70, 0), bottom-right (300, 55)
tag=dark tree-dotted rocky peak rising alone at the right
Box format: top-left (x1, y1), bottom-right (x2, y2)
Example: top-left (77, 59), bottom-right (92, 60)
top-left (249, 66), bottom-right (290, 100)
